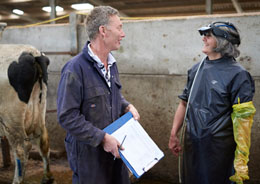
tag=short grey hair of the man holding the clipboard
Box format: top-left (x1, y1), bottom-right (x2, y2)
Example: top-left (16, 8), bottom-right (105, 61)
top-left (86, 6), bottom-right (119, 41)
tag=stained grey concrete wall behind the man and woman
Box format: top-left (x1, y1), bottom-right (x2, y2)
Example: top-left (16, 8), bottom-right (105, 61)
top-left (0, 14), bottom-right (260, 182)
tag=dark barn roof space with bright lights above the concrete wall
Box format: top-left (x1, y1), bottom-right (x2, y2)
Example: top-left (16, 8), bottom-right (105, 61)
top-left (0, 0), bottom-right (260, 26)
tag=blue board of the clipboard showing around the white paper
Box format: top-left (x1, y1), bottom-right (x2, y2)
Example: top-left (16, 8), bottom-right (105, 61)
top-left (103, 112), bottom-right (161, 178)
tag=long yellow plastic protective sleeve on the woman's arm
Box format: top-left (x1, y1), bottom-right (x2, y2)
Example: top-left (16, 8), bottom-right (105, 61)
top-left (229, 101), bottom-right (256, 184)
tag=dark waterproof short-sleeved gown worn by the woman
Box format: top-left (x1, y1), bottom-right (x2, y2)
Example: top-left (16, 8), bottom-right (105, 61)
top-left (179, 57), bottom-right (255, 184)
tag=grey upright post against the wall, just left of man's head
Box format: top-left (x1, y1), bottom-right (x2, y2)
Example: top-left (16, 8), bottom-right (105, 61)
top-left (69, 13), bottom-right (78, 55)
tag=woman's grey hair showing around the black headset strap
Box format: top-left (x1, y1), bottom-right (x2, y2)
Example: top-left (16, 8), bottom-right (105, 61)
top-left (212, 23), bottom-right (240, 58)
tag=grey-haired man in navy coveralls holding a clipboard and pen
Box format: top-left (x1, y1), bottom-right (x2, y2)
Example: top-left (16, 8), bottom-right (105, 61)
top-left (57, 6), bottom-right (139, 184)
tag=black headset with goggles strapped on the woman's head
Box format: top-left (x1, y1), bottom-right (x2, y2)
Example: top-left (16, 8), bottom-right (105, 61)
top-left (198, 22), bottom-right (240, 45)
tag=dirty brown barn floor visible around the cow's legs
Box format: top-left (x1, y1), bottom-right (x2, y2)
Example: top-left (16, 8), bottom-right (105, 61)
top-left (0, 145), bottom-right (173, 184)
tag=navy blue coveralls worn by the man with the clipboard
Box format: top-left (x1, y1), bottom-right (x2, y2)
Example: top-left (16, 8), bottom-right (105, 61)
top-left (57, 42), bottom-right (130, 184)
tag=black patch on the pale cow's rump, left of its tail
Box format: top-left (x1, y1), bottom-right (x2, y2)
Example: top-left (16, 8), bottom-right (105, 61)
top-left (7, 52), bottom-right (37, 103)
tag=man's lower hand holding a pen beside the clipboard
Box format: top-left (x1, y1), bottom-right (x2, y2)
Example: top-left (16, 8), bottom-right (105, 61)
top-left (102, 133), bottom-right (120, 158)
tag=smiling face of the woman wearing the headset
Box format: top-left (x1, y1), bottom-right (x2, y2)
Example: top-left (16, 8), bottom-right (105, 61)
top-left (202, 32), bottom-right (217, 56)
